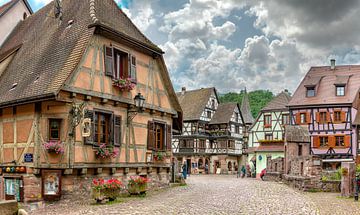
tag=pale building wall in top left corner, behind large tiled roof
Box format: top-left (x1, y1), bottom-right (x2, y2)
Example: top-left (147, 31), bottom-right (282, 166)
top-left (0, 0), bottom-right (33, 47)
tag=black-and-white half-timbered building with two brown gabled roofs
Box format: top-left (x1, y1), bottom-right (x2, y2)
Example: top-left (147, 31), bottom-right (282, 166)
top-left (173, 88), bottom-right (249, 173)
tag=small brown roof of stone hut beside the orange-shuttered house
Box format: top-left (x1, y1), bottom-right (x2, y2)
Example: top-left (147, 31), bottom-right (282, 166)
top-left (285, 125), bottom-right (310, 143)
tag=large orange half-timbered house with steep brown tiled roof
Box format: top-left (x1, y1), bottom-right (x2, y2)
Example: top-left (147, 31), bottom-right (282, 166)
top-left (0, 0), bottom-right (182, 201)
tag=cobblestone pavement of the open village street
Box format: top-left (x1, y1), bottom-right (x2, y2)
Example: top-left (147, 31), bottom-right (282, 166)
top-left (32, 176), bottom-right (360, 215)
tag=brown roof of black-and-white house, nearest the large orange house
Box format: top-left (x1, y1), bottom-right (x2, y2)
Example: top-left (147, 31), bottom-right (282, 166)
top-left (176, 87), bottom-right (216, 120)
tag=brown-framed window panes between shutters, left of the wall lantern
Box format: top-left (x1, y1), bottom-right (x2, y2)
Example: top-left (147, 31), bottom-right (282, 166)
top-left (94, 112), bottom-right (111, 145)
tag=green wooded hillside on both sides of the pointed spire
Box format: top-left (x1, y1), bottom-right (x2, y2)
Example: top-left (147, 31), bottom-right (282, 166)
top-left (220, 90), bottom-right (274, 118)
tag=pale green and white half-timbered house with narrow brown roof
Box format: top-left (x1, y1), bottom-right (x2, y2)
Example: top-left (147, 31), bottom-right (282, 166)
top-left (247, 92), bottom-right (291, 176)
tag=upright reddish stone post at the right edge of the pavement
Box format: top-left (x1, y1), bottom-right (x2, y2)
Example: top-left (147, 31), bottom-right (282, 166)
top-left (341, 162), bottom-right (355, 197)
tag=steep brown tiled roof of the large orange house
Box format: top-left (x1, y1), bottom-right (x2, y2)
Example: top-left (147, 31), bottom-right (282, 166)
top-left (0, 0), bottom-right (169, 107)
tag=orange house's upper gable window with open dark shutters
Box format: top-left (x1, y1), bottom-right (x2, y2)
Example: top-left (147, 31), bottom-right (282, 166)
top-left (105, 47), bottom-right (136, 81)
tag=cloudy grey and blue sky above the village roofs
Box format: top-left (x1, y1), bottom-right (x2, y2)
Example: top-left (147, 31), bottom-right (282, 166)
top-left (0, 0), bottom-right (360, 93)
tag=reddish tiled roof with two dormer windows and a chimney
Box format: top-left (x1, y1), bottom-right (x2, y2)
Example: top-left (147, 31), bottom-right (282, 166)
top-left (288, 65), bottom-right (360, 107)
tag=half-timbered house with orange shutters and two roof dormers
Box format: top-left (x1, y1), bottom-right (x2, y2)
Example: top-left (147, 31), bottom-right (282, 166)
top-left (289, 60), bottom-right (360, 169)
